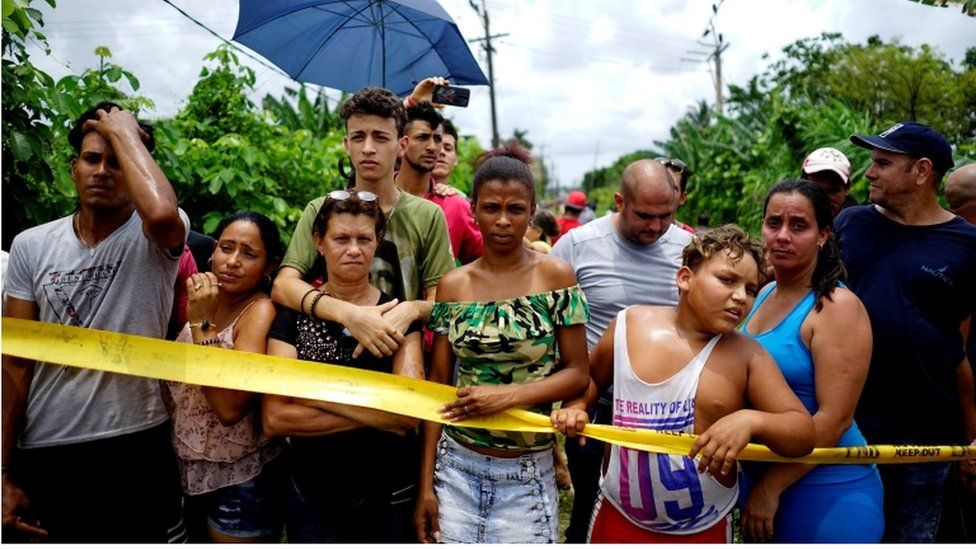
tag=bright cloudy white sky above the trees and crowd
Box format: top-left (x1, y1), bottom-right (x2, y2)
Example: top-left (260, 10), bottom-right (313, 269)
top-left (24, 0), bottom-right (976, 189)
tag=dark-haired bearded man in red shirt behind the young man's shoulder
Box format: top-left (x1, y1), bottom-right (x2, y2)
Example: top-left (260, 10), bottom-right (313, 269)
top-left (396, 101), bottom-right (483, 264)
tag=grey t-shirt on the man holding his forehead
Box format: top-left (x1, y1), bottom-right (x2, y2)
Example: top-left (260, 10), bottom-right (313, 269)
top-left (5, 210), bottom-right (189, 448)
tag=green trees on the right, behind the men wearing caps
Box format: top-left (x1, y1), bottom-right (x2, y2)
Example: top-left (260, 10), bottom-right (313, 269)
top-left (583, 33), bottom-right (976, 232)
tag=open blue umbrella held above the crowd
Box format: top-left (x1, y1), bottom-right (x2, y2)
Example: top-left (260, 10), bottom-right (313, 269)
top-left (234, 0), bottom-right (488, 95)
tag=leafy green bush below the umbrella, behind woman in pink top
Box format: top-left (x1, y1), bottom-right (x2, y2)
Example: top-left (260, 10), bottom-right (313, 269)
top-left (157, 46), bottom-right (344, 240)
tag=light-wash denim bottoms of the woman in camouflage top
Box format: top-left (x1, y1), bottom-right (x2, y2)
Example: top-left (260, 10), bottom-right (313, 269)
top-left (434, 434), bottom-right (559, 543)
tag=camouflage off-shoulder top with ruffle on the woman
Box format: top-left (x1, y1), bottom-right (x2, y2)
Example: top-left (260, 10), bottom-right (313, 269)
top-left (428, 285), bottom-right (590, 450)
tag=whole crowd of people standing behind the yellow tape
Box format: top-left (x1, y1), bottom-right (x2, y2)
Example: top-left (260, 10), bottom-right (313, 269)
top-left (2, 78), bottom-right (976, 543)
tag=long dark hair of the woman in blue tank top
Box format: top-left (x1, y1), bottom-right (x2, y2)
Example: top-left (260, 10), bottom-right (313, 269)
top-left (763, 179), bottom-right (847, 311)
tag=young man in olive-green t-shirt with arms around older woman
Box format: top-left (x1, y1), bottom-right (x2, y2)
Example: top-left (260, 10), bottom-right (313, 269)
top-left (271, 87), bottom-right (454, 357)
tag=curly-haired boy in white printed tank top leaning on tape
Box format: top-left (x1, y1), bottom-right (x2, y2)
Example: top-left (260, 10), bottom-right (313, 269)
top-left (552, 225), bottom-right (814, 543)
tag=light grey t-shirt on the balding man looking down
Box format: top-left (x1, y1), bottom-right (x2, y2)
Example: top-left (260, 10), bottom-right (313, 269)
top-left (552, 215), bottom-right (692, 350)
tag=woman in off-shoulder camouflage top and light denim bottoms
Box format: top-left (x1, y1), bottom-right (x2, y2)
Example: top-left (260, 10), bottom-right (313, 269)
top-left (415, 143), bottom-right (589, 543)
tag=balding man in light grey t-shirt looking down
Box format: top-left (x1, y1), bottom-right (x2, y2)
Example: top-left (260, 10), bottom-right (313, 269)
top-left (552, 159), bottom-right (692, 543)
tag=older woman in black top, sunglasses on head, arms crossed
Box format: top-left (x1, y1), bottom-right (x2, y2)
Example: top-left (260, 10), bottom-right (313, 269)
top-left (262, 190), bottom-right (424, 543)
